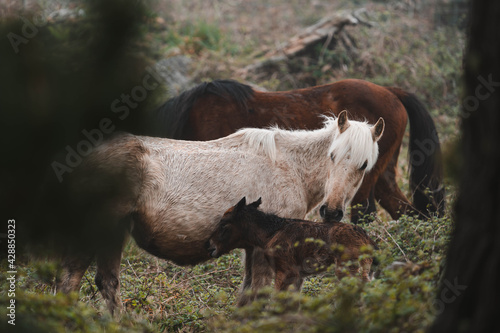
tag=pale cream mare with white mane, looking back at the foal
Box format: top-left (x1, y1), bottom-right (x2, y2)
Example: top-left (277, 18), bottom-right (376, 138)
top-left (58, 112), bottom-right (384, 312)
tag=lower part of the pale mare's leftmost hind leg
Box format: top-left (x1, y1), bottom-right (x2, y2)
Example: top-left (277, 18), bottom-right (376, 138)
top-left (56, 254), bottom-right (93, 294)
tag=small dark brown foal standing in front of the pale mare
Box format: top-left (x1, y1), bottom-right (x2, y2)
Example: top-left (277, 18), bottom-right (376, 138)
top-left (207, 197), bottom-right (378, 291)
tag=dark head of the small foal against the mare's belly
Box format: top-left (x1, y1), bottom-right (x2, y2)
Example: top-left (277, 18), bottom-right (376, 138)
top-left (207, 198), bottom-right (262, 258)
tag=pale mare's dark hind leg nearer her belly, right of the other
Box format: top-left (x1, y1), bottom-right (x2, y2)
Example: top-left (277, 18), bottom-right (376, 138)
top-left (95, 229), bottom-right (126, 315)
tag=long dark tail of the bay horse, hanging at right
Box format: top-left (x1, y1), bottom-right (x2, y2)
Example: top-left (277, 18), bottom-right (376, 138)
top-left (387, 87), bottom-right (445, 216)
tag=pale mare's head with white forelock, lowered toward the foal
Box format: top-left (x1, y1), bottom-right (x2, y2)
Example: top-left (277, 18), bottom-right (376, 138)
top-left (320, 110), bottom-right (384, 222)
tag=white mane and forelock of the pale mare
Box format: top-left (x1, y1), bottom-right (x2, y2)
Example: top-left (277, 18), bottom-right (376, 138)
top-left (237, 116), bottom-right (378, 170)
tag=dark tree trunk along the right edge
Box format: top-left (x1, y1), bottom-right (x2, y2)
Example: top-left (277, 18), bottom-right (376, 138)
top-left (430, 0), bottom-right (500, 332)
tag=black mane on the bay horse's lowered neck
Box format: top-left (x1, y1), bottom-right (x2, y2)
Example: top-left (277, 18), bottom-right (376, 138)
top-left (145, 80), bottom-right (253, 140)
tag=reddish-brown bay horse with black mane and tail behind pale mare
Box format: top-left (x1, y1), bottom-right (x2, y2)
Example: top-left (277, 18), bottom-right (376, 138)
top-left (146, 79), bottom-right (444, 223)
